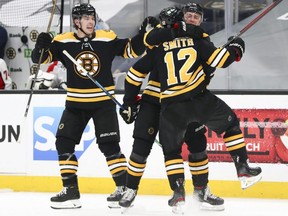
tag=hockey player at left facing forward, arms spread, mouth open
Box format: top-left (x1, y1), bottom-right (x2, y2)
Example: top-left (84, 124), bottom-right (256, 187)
top-left (32, 3), bottom-right (156, 209)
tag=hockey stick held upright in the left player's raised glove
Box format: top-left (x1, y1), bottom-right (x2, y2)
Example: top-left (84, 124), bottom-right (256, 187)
top-left (17, 0), bottom-right (57, 143)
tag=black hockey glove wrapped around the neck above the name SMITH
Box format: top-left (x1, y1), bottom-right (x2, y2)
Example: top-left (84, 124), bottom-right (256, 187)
top-left (173, 21), bottom-right (205, 40)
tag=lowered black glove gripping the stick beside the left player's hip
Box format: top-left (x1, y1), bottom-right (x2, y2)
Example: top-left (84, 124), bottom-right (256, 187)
top-left (119, 96), bottom-right (141, 124)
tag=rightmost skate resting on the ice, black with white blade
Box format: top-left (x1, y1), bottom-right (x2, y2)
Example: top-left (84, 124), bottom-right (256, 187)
top-left (193, 186), bottom-right (225, 211)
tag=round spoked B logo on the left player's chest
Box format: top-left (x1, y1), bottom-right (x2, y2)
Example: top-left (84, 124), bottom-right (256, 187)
top-left (74, 51), bottom-right (101, 79)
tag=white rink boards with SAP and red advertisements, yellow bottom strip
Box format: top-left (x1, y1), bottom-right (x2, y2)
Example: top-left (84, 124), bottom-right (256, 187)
top-left (0, 93), bottom-right (288, 198)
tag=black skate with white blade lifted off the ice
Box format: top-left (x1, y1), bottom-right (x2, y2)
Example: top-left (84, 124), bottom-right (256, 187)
top-left (234, 158), bottom-right (262, 190)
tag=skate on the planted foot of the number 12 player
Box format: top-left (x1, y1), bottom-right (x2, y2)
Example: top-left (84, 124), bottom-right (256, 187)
top-left (168, 179), bottom-right (185, 214)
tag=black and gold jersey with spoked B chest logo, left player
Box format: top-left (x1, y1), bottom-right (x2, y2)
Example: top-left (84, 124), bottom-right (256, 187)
top-left (32, 30), bottom-right (145, 109)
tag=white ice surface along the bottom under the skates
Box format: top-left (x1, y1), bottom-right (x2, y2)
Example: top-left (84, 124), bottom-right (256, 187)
top-left (0, 190), bottom-right (288, 216)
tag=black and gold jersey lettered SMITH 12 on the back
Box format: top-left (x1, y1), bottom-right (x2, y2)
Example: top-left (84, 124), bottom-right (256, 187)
top-left (124, 38), bottom-right (240, 103)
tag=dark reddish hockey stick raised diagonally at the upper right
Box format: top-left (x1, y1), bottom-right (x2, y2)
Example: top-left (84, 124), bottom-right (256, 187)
top-left (222, 0), bottom-right (282, 47)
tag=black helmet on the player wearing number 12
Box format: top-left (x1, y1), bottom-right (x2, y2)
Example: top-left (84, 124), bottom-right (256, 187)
top-left (159, 7), bottom-right (183, 28)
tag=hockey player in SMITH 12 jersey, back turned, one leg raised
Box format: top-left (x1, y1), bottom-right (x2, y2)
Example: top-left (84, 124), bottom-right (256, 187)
top-left (119, 2), bottom-right (261, 213)
